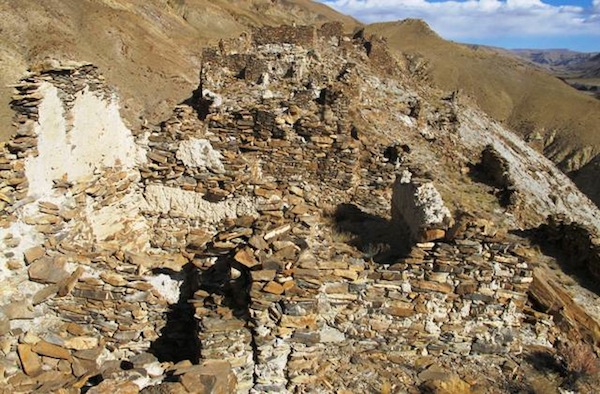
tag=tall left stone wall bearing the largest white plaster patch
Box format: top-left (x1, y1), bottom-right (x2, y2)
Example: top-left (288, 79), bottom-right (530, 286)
top-left (0, 65), bottom-right (221, 392)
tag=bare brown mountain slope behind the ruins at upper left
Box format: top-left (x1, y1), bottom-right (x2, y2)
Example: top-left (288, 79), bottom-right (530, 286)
top-left (0, 0), bottom-right (357, 141)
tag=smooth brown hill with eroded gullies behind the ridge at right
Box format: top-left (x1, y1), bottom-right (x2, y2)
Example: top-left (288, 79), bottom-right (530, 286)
top-left (367, 20), bottom-right (600, 179)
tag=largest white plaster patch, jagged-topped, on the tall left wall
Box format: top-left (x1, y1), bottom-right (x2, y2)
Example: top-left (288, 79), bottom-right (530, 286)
top-left (25, 83), bottom-right (145, 197)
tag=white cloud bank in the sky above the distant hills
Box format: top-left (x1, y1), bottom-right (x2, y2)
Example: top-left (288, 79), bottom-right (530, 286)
top-left (322, 0), bottom-right (600, 40)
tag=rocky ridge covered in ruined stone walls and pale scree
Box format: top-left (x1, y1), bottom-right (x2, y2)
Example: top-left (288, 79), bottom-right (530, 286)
top-left (0, 23), bottom-right (600, 393)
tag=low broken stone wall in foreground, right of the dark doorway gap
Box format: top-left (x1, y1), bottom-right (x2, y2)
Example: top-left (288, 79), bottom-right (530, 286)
top-left (186, 215), bottom-right (532, 392)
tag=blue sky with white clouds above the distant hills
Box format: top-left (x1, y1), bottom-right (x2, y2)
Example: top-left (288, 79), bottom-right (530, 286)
top-left (320, 0), bottom-right (600, 52)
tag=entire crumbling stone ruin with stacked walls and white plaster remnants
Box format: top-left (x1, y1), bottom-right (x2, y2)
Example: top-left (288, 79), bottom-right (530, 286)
top-left (0, 25), bottom-right (584, 393)
